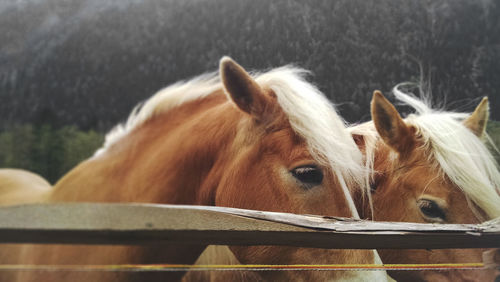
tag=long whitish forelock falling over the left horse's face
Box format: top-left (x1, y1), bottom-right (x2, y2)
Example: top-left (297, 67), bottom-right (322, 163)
top-left (256, 67), bottom-right (366, 218)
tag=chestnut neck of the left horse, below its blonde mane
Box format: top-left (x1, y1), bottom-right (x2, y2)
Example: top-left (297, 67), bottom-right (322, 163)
top-left (50, 93), bottom-right (241, 205)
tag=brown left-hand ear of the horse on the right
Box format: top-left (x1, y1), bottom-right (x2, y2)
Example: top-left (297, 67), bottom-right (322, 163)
top-left (371, 90), bottom-right (415, 154)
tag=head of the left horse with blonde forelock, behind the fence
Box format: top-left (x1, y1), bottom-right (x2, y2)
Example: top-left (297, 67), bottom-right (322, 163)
top-left (215, 59), bottom-right (383, 280)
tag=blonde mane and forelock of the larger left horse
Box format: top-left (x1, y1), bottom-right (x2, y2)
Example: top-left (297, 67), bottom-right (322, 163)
top-left (94, 66), bottom-right (366, 216)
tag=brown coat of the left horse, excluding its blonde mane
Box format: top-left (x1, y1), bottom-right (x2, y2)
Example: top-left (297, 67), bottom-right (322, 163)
top-left (0, 59), bottom-right (373, 281)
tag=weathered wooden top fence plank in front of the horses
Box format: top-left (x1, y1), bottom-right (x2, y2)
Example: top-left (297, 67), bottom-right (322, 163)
top-left (0, 203), bottom-right (500, 249)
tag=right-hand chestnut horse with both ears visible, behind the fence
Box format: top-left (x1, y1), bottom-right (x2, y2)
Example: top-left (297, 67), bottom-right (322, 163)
top-left (351, 90), bottom-right (500, 281)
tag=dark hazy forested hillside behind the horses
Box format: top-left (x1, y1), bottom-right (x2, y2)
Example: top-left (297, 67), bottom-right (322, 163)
top-left (0, 0), bottom-right (500, 182)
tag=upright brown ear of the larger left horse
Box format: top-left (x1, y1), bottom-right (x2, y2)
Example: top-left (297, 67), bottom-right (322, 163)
top-left (219, 57), bottom-right (267, 116)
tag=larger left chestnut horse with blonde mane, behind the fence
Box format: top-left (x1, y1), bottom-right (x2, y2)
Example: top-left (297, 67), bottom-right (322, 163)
top-left (0, 57), bottom-right (385, 281)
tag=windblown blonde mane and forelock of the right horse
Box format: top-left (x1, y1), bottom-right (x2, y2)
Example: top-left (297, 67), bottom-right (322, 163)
top-left (351, 86), bottom-right (500, 218)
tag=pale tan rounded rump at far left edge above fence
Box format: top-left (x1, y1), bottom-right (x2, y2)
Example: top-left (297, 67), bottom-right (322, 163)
top-left (0, 168), bottom-right (52, 206)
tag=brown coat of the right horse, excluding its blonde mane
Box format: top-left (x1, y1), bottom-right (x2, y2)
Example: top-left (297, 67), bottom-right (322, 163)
top-left (357, 92), bottom-right (496, 281)
